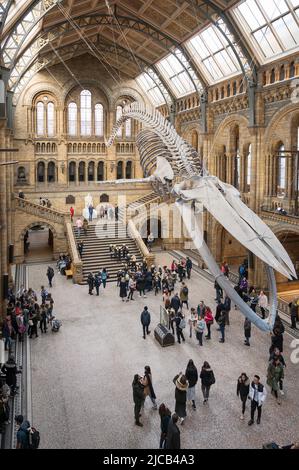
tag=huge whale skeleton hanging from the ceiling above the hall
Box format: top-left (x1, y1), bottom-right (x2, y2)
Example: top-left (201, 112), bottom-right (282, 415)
top-left (107, 102), bottom-right (297, 332)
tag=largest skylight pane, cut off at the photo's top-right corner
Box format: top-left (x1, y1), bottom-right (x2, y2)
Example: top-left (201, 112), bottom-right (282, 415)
top-left (233, 0), bottom-right (299, 62)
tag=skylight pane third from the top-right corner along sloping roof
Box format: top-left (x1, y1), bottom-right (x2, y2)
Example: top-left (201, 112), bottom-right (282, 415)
top-left (157, 54), bottom-right (195, 98)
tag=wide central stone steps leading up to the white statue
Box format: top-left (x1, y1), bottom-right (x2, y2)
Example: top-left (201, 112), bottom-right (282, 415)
top-left (73, 220), bottom-right (142, 284)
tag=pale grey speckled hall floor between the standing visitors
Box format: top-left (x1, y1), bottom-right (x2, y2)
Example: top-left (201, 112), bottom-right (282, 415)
top-left (29, 253), bottom-right (299, 449)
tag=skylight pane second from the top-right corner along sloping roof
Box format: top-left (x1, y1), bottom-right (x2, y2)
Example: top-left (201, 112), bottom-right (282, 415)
top-left (186, 25), bottom-right (241, 82)
